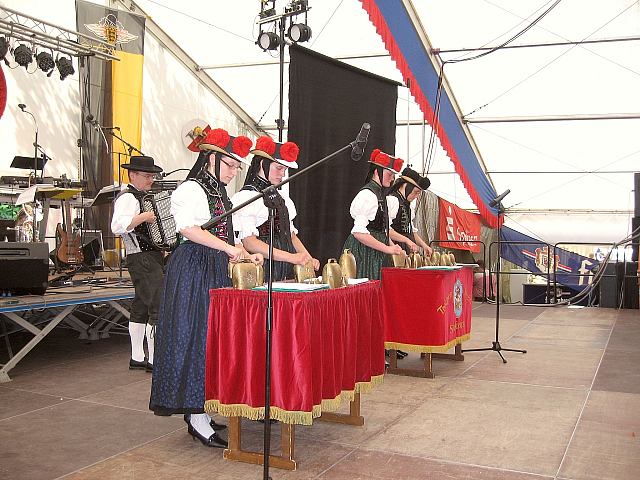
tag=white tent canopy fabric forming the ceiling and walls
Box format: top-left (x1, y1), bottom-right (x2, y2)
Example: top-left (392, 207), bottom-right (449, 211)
top-left (0, 0), bottom-right (640, 246)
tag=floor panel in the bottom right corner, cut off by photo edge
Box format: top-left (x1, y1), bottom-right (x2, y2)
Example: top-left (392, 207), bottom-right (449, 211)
top-left (560, 392), bottom-right (640, 480)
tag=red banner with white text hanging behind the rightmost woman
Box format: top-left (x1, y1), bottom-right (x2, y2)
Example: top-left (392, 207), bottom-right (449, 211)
top-left (439, 198), bottom-right (480, 253)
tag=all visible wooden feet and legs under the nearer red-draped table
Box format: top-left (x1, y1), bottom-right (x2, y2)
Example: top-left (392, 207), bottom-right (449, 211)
top-left (222, 393), bottom-right (364, 470)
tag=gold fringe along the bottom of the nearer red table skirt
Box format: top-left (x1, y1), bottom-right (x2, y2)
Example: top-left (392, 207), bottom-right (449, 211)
top-left (204, 375), bottom-right (384, 425)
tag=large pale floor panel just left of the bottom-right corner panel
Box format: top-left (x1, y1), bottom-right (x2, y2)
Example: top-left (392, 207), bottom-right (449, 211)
top-left (363, 380), bottom-right (586, 475)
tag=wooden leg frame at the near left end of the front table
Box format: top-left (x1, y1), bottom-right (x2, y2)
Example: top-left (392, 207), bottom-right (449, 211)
top-left (222, 417), bottom-right (297, 470)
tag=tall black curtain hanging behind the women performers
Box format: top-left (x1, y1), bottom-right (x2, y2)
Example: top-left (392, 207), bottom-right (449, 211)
top-left (288, 45), bottom-right (400, 266)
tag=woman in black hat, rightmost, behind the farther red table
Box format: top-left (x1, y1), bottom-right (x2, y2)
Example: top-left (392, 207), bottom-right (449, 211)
top-left (388, 167), bottom-right (433, 255)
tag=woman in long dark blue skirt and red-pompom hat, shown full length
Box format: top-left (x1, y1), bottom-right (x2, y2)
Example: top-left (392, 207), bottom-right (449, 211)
top-left (149, 129), bottom-right (262, 447)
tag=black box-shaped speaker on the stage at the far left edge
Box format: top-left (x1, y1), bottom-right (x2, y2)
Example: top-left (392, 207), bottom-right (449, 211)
top-left (0, 242), bottom-right (49, 295)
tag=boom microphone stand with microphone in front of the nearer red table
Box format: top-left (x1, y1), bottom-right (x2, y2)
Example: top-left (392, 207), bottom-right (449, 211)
top-left (201, 138), bottom-right (358, 480)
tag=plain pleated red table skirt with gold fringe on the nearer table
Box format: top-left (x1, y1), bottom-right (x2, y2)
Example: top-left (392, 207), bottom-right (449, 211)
top-left (205, 281), bottom-right (384, 425)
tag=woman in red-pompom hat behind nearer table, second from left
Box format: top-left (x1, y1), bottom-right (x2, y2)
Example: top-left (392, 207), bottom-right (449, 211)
top-left (231, 136), bottom-right (320, 281)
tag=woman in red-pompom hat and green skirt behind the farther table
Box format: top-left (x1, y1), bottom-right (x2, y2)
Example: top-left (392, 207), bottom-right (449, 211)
top-left (343, 149), bottom-right (403, 280)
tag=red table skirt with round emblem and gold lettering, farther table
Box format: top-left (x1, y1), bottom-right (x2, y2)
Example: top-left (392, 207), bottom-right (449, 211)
top-left (382, 267), bottom-right (473, 353)
